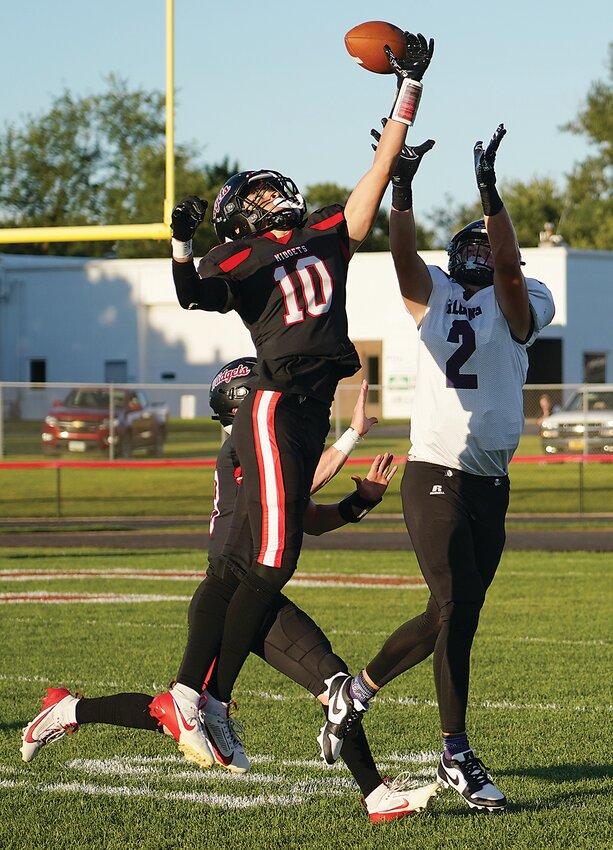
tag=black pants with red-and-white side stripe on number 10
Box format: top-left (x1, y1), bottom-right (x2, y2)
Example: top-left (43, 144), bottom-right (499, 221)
top-left (217, 390), bottom-right (329, 700)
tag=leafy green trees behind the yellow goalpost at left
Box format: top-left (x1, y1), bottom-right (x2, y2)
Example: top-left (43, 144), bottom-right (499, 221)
top-left (0, 76), bottom-right (237, 257)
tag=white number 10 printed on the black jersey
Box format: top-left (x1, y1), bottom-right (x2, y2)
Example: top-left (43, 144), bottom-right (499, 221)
top-left (274, 256), bottom-right (333, 325)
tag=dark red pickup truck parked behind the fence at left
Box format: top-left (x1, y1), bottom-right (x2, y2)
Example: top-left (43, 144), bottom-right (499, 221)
top-left (41, 387), bottom-right (168, 457)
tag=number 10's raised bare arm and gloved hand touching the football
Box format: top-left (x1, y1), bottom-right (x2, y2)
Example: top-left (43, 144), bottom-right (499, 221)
top-left (345, 33), bottom-right (434, 255)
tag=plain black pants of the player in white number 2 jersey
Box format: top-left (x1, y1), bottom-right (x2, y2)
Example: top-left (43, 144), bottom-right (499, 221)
top-left (366, 461), bottom-right (509, 734)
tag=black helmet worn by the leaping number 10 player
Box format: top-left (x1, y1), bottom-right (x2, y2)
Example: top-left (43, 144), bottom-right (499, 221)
top-left (212, 171), bottom-right (306, 242)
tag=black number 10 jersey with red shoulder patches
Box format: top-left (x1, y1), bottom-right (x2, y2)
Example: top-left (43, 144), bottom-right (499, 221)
top-left (196, 205), bottom-right (360, 404)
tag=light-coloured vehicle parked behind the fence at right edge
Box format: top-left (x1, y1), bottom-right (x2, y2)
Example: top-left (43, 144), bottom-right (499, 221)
top-left (541, 386), bottom-right (613, 454)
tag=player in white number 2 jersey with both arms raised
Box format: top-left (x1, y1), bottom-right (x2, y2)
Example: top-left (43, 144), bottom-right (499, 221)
top-left (322, 124), bottom-right (554, 811)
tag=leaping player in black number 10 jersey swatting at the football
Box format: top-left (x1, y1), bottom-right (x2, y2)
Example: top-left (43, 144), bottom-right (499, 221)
top-left (157, 28), bottom-right (434, 780)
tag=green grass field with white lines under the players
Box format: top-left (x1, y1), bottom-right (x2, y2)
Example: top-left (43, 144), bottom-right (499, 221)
top-left (0, 549), bottom-right (613, 850)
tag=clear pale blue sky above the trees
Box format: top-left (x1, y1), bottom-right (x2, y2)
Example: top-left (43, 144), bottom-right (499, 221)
top-left (0, 0), bottom-right (613, 224)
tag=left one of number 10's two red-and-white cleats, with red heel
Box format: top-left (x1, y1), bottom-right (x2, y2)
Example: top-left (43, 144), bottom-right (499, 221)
top-left (149, 688), bottom-right (214, 767)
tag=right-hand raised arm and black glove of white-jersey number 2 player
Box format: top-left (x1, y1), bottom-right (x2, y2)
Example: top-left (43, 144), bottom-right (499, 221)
top-left (473, 124), bottom-right (532, 341)
